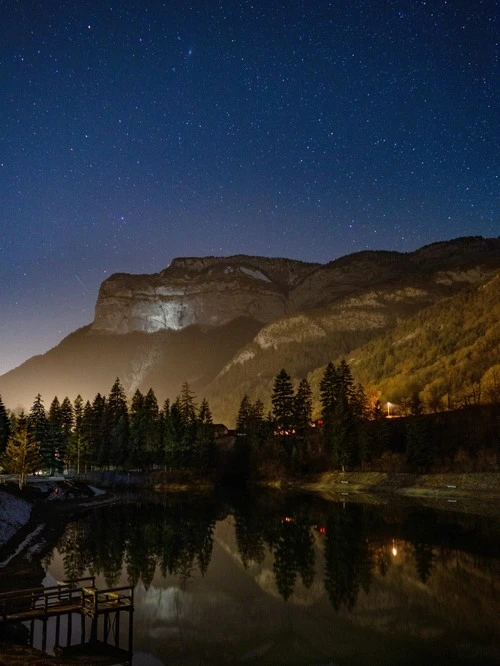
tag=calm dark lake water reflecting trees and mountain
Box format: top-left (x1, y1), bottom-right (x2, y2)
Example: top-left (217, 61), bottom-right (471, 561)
top-left (36, 494), bottom-right (500, 666)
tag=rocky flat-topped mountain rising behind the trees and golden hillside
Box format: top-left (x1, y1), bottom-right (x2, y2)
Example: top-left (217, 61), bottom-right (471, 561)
top-left (0, 237), bottom-right (500, 423)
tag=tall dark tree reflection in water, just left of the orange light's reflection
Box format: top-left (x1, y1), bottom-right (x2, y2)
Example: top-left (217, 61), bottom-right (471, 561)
top-left (325, 504), bottom-right (373, 610)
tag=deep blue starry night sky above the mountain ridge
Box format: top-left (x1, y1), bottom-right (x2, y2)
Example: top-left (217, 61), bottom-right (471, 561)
top-left (0, 0), bottom-right (500, 374)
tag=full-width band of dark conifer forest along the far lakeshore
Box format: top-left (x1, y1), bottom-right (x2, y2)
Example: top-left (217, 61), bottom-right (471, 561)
top-left (0, 360), bottom-right (500, 487)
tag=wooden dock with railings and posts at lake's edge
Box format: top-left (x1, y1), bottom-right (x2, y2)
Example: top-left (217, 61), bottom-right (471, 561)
top-left (0, 577), bottom-right (134, 661)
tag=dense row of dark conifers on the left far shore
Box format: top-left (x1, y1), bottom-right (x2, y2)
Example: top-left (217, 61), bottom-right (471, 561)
top-left (0, 378), bottom-right (214, 486)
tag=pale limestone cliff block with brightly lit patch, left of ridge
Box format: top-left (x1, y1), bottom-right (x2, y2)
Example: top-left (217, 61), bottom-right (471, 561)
top-left (92, 256), bottom-right (315, 334)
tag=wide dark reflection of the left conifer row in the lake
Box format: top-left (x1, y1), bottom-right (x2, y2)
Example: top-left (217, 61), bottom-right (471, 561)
top-left (60, 500), bottom-right (216, 587)
